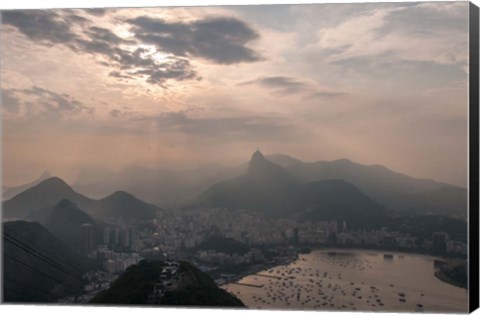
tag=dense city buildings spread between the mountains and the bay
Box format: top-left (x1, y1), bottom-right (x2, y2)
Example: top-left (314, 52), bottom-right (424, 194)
top-left (56, 204), bottom-right (467, 302)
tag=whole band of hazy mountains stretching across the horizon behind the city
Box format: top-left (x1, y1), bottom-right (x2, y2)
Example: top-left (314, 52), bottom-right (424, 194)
top-left (4, 152), bottom-right (467, 220)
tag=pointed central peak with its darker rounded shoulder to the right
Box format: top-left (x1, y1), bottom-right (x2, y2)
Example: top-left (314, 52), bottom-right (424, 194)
top-left (197, 151), bottom-right (388, 225)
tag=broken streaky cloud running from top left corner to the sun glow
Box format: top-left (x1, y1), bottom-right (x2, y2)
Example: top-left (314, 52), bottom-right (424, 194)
top-left (3, 10), bottom-right (200, 86)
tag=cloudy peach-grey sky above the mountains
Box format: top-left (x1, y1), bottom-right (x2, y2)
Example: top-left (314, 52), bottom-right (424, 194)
top-left (1, 2), bottom-right (468, 186)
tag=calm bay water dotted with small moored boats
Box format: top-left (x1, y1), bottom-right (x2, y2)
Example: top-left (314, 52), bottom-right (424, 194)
top-left (223, 250), bottom-right (468, 312)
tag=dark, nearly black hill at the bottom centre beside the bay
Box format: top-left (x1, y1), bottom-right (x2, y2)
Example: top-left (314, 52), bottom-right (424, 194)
top-left (90, 260), bottom-right (244, 307)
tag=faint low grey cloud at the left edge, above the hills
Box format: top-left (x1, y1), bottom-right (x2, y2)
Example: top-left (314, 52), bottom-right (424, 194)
top-left (2, 86), bottom-right (94, 117)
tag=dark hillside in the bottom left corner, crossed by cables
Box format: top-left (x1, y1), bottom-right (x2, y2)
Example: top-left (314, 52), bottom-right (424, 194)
top-left (3, 221), bottom-right (95, 303)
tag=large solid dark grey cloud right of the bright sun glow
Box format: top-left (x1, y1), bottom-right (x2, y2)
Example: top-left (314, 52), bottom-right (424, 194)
top-left (127, 16), bottom-right (261, 64)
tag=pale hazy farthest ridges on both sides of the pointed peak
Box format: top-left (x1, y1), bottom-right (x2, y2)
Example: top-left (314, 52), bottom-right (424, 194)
top-left (67, 154), bottom-right (467, 219)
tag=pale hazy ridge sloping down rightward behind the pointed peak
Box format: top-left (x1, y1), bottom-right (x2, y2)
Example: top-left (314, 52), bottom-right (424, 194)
top-left (268, 155), bottom-right (467, 219)
